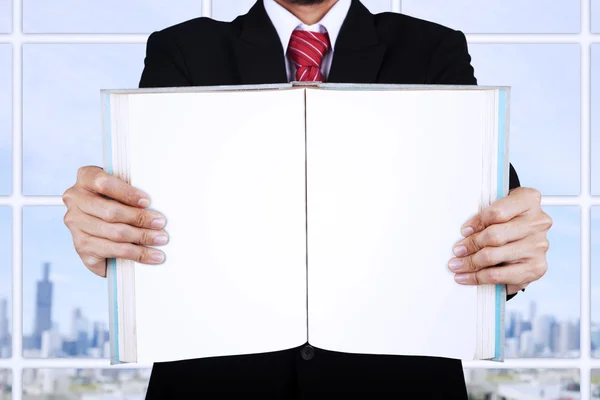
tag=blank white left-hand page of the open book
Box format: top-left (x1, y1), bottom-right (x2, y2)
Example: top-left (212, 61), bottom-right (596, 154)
top-left (129, 90), bottom-right (306, 362)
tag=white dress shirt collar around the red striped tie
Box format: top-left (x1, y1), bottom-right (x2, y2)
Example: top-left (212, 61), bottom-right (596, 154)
top-left (264, 0), bottom-right (352, 81)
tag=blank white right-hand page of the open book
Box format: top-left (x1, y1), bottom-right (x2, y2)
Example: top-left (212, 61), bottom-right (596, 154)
top-left (307, 90), bottom-right (489, 359)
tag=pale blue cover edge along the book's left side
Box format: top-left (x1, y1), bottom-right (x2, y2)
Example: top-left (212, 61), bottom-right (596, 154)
top-left (101, 92), bottom-right (120, 364)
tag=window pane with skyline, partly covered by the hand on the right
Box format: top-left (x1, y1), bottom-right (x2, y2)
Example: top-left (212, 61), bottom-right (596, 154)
top-left (505, 206), bottom-right (581, 358)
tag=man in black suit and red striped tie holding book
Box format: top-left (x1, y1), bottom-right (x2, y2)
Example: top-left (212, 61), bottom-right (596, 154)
top-left (64, 0), bottom-right (552, 399)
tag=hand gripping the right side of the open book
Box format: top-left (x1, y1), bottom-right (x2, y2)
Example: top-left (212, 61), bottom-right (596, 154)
top-left (448, 187), bottom-right (552, 294)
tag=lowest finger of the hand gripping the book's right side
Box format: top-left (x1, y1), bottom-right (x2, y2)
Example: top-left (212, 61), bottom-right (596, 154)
top-left (454, 259), bottom-right (548, 287)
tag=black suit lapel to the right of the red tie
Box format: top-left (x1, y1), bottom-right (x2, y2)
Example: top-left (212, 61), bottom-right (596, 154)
top-left (327, 0), bottom-right (386, 83)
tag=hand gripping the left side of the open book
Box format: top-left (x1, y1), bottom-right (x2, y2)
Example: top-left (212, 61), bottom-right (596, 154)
top-left (63, 166), bottom-right (168, 277)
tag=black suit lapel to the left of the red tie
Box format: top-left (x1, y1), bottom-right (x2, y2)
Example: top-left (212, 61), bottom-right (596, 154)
top-left (233, 0), bottom-right (288, 85)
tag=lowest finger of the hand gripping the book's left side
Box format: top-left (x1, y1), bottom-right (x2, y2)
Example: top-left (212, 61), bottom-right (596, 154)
top-left (74, 233), bottom-right (165, 265)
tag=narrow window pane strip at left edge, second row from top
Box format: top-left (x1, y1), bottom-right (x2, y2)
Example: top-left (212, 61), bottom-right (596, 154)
top-left (0, 45), bottom-right (12, 196)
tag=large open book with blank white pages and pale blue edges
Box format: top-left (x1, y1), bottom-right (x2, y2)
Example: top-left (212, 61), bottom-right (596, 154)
top-left (102, 83), bottom-right (509, 363)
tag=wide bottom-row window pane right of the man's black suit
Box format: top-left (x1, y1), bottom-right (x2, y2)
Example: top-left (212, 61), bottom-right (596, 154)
top-left (465, 369), bottom-right (581, 400)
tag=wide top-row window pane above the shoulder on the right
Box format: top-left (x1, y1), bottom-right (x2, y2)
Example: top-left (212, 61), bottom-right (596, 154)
top-left (402, 0), bottom-right (580, 33)
